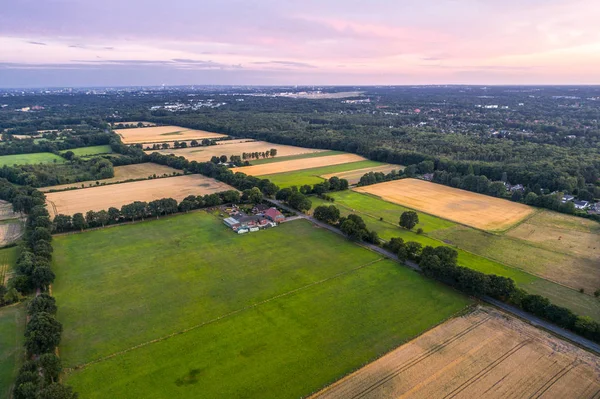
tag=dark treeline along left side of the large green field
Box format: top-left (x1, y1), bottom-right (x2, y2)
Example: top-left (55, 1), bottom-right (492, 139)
top-left (0, 179), bottom-right (77, 399)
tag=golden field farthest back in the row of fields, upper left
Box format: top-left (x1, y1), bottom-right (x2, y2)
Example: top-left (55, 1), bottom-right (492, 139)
top-left (115, 126), bottom-right (226, 144)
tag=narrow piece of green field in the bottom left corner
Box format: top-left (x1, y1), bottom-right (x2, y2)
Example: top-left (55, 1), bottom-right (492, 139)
top-left (0, 304), bottom-right (26, 398)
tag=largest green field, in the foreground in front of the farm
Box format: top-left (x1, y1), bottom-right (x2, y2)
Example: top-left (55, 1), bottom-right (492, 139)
top-left (53, 212), bottom-right (470, 398)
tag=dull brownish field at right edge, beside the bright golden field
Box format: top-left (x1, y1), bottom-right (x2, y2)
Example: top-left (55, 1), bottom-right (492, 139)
top-left (506, 211), bottom-right (600, 264)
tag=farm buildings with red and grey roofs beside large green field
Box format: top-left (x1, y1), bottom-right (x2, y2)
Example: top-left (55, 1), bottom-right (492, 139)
top-left (223, 204), bottom-right (285, 234)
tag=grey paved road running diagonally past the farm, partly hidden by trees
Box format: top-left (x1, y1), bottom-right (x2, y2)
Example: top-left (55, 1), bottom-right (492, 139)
top-left (267, 199), bottom-right (600, 354)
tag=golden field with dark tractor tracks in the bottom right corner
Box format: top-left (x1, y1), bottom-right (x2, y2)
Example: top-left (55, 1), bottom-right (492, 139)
top-left (312, 308), bottom-right (600, 399)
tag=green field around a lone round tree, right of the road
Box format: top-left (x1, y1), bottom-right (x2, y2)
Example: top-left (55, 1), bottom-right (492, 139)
top-left (310, 190), bottom-right (600, 321)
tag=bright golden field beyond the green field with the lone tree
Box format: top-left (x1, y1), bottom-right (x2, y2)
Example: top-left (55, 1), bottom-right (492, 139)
top-left (355, 179), bottom-right (535, 230)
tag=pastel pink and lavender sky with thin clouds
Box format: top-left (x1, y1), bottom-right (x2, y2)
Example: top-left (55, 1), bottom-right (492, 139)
top-left (0, 0), bottom-right (600, 87)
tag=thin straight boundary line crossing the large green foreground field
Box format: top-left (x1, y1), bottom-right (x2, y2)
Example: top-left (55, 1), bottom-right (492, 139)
top-left (63, 257), bottom-right (386, 375)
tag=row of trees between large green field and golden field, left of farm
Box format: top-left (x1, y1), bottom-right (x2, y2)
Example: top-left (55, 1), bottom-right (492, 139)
top-left (52, 188), bottom-right (243, 233)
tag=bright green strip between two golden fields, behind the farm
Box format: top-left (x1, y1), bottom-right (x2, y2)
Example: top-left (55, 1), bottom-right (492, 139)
top-left (258, 161), bottom-right (384, 188)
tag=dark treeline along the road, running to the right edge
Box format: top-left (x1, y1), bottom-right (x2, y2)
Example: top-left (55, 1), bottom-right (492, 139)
top-left (383, 238), bottom-right (600, 342)
